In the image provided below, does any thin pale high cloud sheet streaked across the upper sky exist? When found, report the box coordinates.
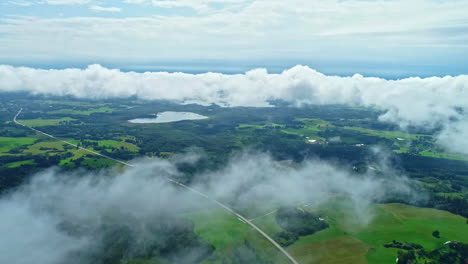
[0,0,468,61]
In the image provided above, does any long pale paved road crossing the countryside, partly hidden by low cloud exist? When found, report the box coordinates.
[13,108,299,264]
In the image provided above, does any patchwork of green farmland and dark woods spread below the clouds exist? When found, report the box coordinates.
[0,94,468,264]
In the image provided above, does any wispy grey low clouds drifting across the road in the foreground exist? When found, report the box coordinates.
[0,154,411,264]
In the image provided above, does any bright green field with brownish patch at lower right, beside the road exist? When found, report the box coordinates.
[255,200,468,264]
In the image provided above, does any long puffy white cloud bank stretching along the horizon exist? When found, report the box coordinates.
[0,65,468,154]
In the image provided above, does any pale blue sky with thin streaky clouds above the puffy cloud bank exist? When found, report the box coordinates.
[0,0,468,76]
